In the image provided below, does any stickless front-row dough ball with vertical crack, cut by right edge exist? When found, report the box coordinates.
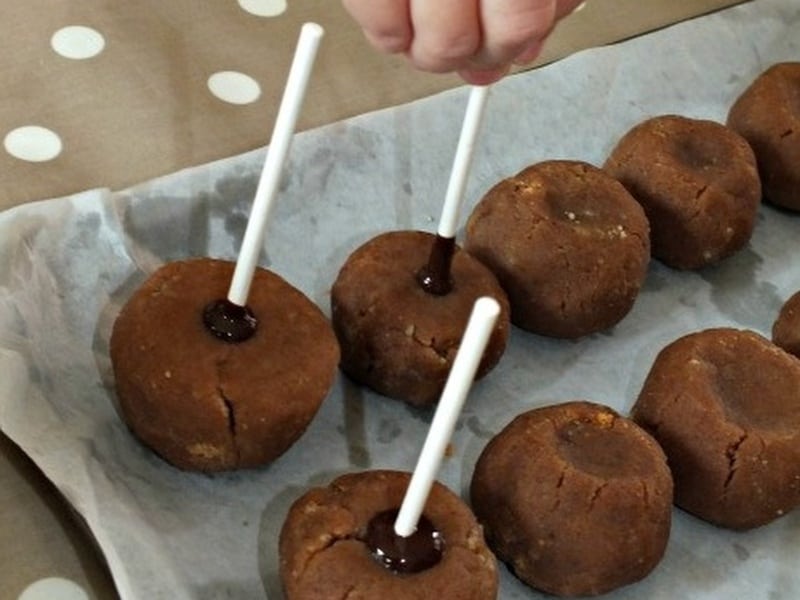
[632,328,800,529]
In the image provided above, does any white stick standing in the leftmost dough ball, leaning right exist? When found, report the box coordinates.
[228,23,324,306]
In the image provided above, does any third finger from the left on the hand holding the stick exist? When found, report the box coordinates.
[475,0,557,66]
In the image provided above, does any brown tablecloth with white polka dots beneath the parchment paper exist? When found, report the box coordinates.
[0,0,757,600]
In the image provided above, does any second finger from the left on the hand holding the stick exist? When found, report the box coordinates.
[409,0,481,73]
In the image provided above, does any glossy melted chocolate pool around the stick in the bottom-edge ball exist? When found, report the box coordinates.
[364,509,444,573]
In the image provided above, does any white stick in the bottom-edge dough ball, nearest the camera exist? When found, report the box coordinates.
[394,296,500,537]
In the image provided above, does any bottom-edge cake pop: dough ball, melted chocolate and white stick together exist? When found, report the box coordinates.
[280,297,500,600]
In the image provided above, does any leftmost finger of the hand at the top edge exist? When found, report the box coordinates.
[342,0,414,53]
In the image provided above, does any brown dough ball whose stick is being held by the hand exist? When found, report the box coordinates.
[331,231,510,406]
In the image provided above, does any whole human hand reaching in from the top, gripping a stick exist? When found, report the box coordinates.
[342,0,582,85]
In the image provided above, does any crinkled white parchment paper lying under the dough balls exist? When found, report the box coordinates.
[0,0,800,600]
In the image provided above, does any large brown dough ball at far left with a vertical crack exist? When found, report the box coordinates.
[110,258,339,471]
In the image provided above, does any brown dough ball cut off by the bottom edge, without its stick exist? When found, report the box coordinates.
[279,471,498,600]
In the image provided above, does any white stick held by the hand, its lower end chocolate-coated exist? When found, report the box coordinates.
[437,85,489,238]
